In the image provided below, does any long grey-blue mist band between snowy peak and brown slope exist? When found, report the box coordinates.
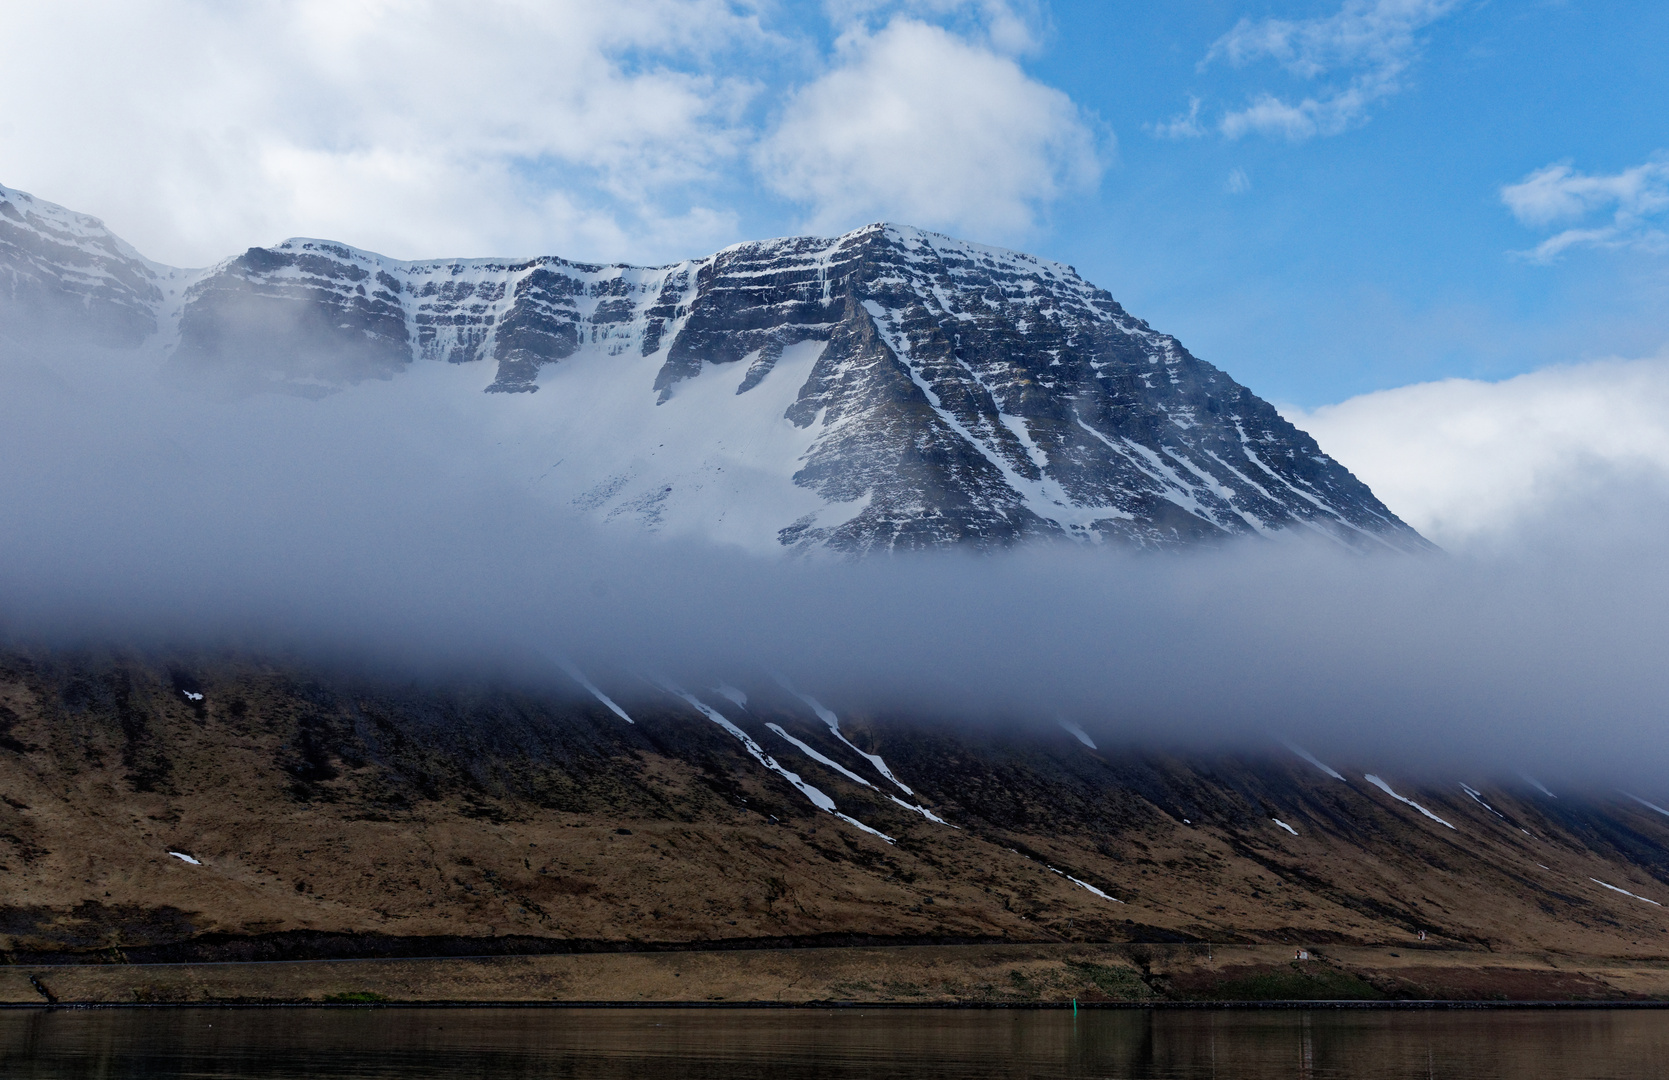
[0,181,1669,785]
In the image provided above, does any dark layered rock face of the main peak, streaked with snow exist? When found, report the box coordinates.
[637,225,1422,551]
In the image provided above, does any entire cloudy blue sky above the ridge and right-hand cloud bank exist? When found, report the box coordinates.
[0,0,1669,409]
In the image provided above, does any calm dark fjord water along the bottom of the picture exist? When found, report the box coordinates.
[0,1008,1669,1080]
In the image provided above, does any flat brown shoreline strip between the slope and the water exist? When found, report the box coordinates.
[0,943,1669,1010]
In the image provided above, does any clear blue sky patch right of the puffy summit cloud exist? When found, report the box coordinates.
[1033,2,1669,404]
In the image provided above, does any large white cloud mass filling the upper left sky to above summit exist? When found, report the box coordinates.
[0,0,1098,265]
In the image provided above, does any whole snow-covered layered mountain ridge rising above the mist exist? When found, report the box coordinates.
[0,187,1427,553]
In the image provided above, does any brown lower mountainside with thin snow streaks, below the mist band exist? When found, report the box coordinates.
[0,654,1669,960]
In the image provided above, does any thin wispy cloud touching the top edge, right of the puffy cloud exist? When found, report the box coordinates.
[1200,0,1460,142]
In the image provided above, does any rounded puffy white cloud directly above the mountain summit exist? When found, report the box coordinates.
[758,17,1100,237]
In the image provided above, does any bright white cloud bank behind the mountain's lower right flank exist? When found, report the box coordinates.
[1285,354,1669,546]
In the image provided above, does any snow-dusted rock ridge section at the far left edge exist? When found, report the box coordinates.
[0,187,164,349]
